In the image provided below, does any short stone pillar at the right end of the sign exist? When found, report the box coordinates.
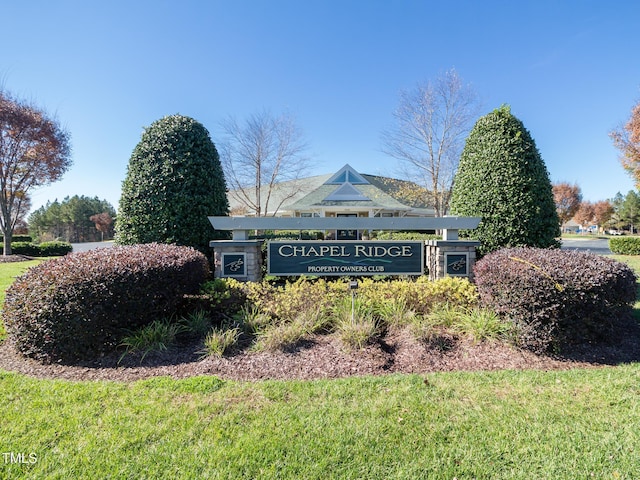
[426,240,480,280]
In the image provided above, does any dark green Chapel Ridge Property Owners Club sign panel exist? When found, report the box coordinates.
[267,241,424,276]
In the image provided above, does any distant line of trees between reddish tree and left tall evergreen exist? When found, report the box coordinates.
[28,195,116,243]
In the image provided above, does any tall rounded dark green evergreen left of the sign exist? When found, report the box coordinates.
[116,115,229,252]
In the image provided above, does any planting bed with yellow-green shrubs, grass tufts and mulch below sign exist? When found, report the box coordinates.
[0,251,638,380]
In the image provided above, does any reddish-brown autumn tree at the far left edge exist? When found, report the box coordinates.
[0,90,71,255]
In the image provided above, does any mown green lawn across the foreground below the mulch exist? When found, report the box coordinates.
[0,258,640,479]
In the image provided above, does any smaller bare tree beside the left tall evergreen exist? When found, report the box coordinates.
[220,111,309,217]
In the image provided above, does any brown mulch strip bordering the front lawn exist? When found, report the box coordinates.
[0,322,640,381]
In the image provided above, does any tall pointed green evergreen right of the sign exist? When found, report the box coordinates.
[451,106,560,254]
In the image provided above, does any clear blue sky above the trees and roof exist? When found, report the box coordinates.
[0,0,640,214]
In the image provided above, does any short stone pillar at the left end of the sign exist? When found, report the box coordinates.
[209,240,263,282]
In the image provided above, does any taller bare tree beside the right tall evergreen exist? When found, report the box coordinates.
[382,69,480,216]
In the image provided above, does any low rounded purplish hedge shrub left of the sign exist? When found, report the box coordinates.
[3,244,209,362]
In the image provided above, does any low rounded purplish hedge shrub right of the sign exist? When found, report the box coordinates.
[474,248,636,353]
